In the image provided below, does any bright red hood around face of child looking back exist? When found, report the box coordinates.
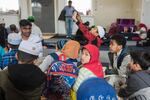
[83,44,104,78]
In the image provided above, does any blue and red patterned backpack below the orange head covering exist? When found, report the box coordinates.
[44,53,78,100]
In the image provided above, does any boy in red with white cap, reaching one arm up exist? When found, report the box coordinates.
[73,12,105,47]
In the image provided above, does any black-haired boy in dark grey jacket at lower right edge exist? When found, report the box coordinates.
[118,51,150,100]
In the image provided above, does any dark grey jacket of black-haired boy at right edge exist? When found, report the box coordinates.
[118,71,150,100]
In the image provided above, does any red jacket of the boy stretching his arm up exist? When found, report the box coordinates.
[77,22,103,48]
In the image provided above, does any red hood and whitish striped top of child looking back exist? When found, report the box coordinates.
[73,44,104,91]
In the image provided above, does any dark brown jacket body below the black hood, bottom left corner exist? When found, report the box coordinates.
[0,70,42,100]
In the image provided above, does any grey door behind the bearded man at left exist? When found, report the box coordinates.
[32,0,55,33]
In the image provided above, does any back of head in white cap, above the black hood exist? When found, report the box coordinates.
[16,40,40,64]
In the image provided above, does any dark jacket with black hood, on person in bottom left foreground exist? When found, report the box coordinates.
[0,64,46,100]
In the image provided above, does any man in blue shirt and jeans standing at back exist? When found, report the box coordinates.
[58,0,75,38]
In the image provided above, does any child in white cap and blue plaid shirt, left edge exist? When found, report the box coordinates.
[0,33,21,69]
